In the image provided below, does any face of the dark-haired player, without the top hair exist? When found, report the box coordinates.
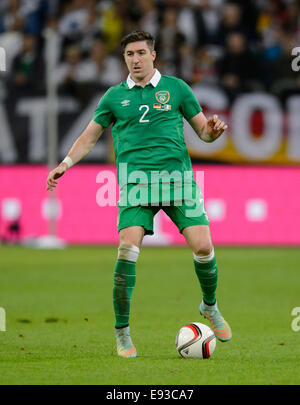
[124,41,156,81]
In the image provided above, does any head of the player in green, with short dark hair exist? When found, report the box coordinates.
[121,31,156,80]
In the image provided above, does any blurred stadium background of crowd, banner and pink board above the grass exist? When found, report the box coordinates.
[0,0,300,246]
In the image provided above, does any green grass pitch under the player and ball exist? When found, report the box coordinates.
[0,247,300,385]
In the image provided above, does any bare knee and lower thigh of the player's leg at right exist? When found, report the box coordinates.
[182,225,213,256]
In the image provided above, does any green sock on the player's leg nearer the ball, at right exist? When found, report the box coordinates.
[194,256,218,305]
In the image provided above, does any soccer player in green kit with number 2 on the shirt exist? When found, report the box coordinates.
[47,31,232,358]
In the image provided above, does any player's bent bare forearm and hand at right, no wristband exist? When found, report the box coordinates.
[189,112,228,142]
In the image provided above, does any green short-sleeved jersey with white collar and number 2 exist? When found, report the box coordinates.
[93,70,202,183]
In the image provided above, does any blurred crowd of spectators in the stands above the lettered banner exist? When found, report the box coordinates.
[0,0,300,102]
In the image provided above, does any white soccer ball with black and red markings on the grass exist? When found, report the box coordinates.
[175,322,216,359]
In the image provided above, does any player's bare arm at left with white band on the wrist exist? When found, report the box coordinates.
[47,120,104,191]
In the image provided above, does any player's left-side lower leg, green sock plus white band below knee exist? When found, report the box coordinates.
[113,244,139,328]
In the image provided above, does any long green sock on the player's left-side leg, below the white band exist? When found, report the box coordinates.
[113,259,135,328]
